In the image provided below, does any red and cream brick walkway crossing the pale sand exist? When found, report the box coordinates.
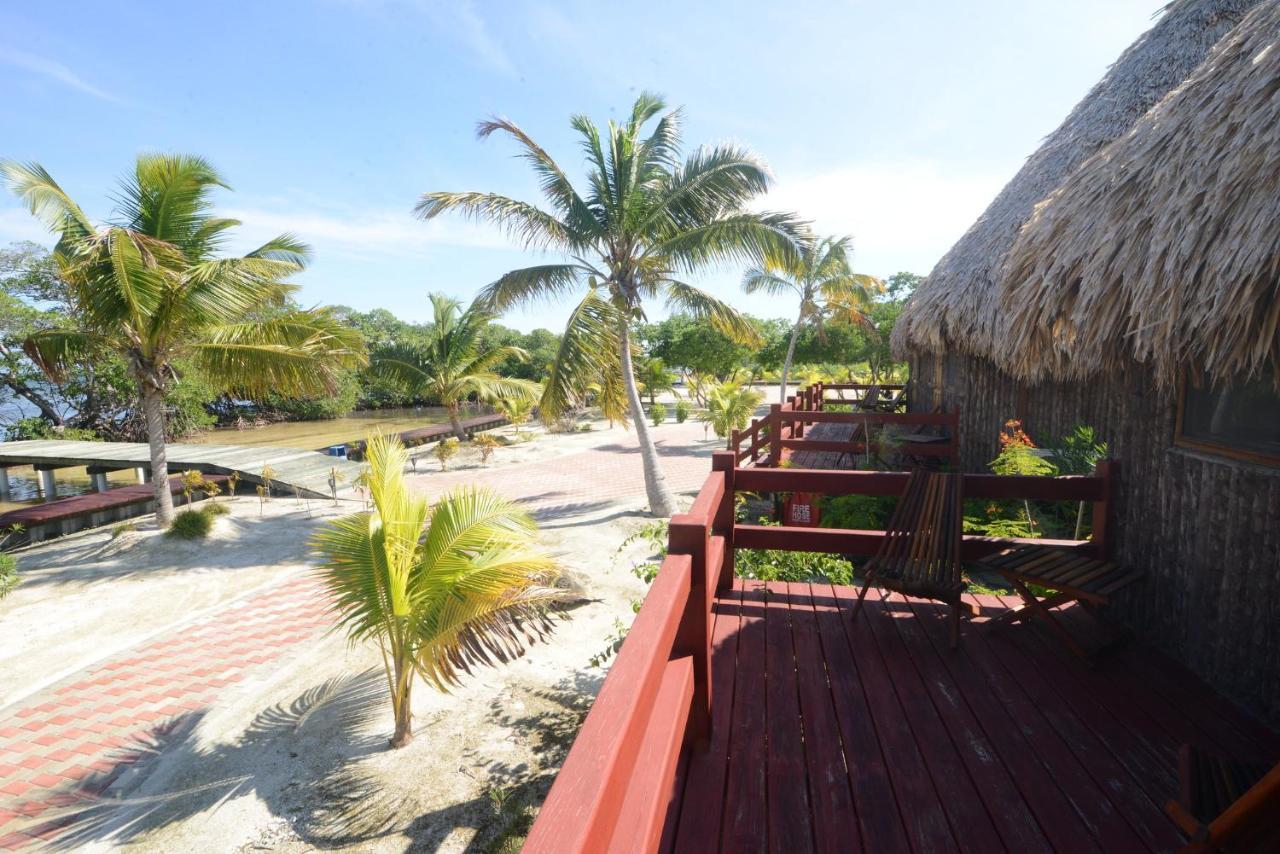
[0,424,709,850]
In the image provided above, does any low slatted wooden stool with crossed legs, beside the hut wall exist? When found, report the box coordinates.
[980,545,1142,659]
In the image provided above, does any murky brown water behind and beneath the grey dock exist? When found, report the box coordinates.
[0,406,460,512]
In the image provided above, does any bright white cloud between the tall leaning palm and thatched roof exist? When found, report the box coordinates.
[764,160,1009,275]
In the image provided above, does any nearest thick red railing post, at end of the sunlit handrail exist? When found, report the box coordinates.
[667,513,712,744]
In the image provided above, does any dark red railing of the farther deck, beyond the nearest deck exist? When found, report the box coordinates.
[728,383,960,467]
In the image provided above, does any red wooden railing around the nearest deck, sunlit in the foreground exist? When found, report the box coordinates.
[525,451,1116,854]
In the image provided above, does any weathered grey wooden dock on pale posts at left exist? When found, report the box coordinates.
[0,440,362,498]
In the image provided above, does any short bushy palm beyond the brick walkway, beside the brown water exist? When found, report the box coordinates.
[371,293,538,439]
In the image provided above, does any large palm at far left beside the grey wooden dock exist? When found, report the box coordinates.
[0,154,364,525]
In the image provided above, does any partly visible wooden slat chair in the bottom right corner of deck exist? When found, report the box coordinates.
[1165,744,1280,853]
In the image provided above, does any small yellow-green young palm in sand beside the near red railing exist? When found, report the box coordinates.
[312,435,559,748]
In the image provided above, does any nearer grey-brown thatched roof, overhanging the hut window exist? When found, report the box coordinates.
[993,0,1280,383]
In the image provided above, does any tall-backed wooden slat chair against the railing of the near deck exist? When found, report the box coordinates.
[852,469,965,649]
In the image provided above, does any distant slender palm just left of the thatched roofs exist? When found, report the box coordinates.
[742,237,884,403]
